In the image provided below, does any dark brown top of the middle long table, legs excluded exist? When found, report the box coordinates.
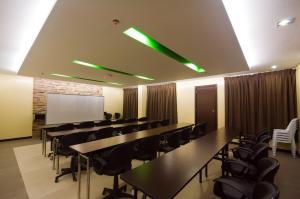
[70,123,193,154]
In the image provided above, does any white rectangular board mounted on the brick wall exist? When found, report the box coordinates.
[46,93,104,124]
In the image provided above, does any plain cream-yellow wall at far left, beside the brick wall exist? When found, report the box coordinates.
[0,74,33,140]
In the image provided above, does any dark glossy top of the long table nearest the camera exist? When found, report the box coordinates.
[121,128,236,199]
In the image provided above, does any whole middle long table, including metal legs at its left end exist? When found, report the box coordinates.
[70,123,193,199]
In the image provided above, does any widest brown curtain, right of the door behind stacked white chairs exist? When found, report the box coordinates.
[225,69,297,134]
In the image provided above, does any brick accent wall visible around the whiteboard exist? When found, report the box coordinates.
[32,78,103,136]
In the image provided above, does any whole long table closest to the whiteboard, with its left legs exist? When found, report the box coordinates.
[42,121,151,157]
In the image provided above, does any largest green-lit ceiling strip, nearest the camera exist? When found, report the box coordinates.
[123,27,205,73]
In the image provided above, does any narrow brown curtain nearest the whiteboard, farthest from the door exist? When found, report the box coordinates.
[123,88,138,119]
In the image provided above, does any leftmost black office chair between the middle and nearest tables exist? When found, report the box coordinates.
[93,143,133,198]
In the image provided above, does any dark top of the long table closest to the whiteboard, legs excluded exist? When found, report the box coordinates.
[47,121,150,137]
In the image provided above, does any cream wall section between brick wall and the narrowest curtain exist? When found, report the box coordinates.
[102,86,123,115]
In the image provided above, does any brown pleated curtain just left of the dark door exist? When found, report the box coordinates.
[147,83,177,124]
